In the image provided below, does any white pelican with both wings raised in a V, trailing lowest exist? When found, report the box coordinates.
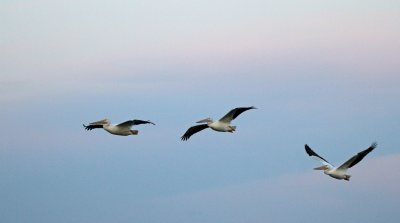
[305,142,378,181]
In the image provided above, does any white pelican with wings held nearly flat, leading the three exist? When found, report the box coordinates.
[83,119,155,136]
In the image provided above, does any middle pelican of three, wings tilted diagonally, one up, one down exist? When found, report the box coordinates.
[181,106,255,141]
